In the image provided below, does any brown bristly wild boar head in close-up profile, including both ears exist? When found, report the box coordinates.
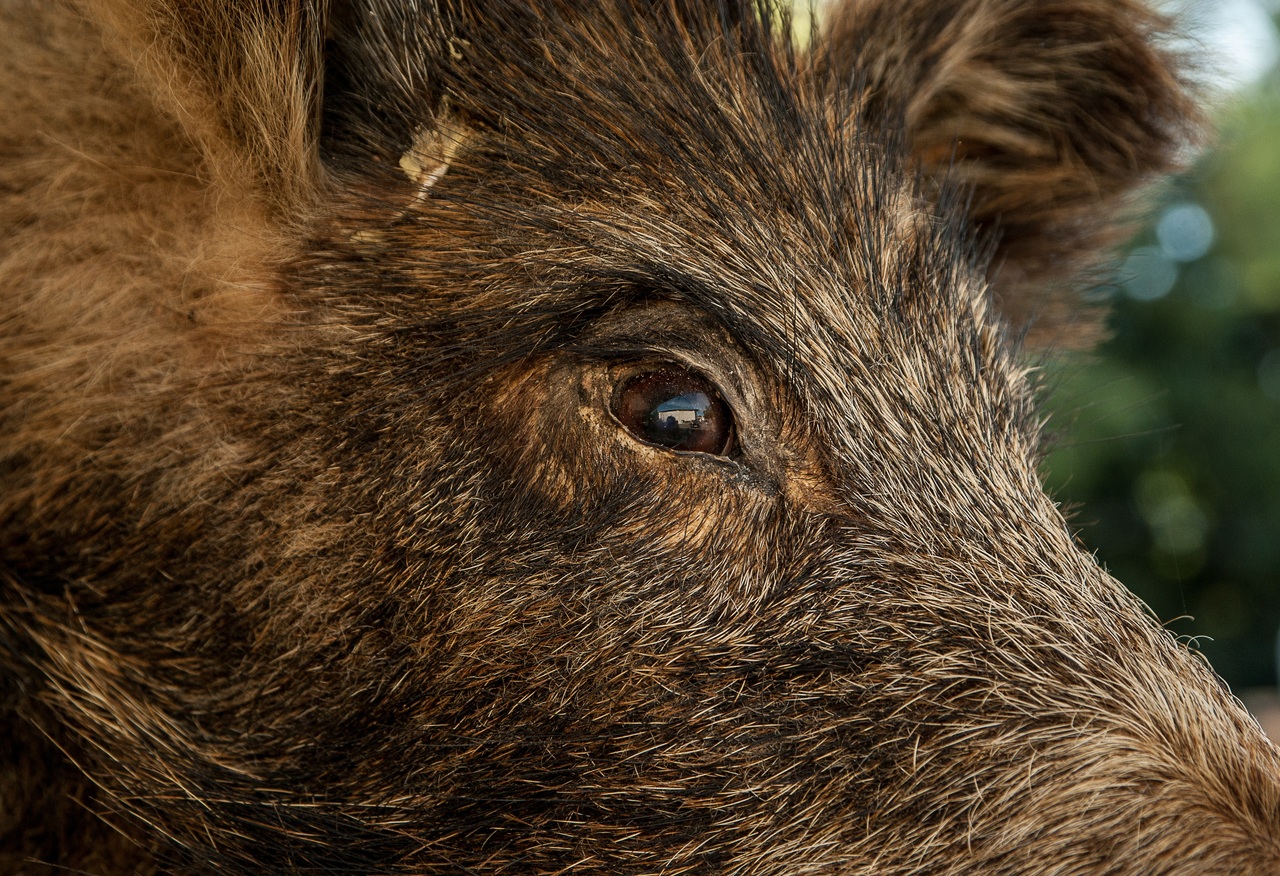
[0,0,1280,876]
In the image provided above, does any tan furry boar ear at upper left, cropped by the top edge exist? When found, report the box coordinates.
[88,0,326,209]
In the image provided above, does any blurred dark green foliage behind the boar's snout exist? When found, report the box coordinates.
[1044,49,1280,689]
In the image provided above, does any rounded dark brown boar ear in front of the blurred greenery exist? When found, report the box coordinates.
[817,0,1201,346]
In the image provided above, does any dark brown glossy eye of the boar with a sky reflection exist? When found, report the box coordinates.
[613,366,733,456]
